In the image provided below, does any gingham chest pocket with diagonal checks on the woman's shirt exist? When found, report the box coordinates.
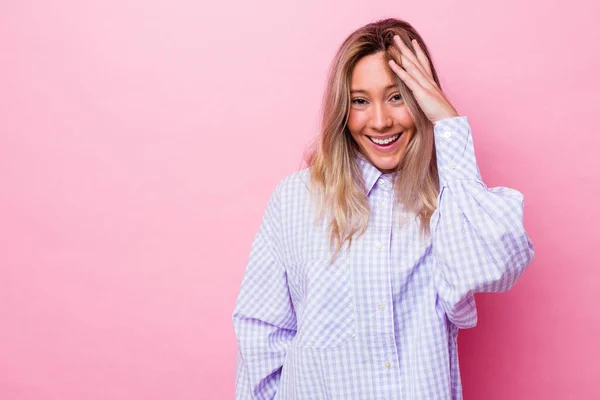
[290,254,356,349]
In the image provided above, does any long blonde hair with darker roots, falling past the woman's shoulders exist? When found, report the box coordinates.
[306,18,441,258]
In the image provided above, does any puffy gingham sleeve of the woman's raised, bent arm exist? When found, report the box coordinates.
[430,117,534,328]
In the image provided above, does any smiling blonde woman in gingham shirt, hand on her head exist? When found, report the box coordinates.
[233,19,534,400]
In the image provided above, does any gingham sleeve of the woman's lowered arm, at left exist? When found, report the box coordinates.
[232,182,296,400]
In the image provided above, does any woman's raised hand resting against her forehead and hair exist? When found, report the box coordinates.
[389,35,458,124]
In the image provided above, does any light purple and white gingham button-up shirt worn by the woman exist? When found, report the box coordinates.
[233,116,534,400]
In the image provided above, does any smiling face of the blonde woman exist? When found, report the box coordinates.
[348,51,415,173]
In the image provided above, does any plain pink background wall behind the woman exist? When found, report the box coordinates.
[0,0,600,400]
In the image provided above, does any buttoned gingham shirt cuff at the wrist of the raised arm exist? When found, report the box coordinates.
[433,116,482,185]
